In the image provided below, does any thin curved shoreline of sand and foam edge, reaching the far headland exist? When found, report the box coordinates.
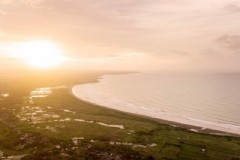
[71,76,240,137]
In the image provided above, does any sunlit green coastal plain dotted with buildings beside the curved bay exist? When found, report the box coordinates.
[0,75,240,160]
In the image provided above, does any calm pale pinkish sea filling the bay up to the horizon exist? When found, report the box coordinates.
[73,73,240,133]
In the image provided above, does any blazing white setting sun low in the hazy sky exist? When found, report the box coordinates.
[15,40,66,69]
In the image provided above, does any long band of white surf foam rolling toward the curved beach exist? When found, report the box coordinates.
[72,75,240,135]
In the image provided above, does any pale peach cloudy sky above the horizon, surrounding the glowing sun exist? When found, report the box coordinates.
[0,0,240,72]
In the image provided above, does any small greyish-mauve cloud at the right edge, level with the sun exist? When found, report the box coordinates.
[216,35,240,50]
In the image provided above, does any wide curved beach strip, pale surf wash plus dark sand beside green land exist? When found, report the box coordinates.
[72,83,240,136]
